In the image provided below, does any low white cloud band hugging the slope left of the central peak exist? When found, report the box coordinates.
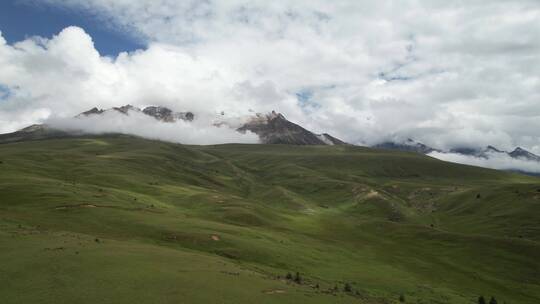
[45,111,259,145]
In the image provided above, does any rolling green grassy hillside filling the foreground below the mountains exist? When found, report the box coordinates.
[0,136,540,303]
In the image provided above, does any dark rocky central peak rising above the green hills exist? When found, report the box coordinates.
[237,111,346,145]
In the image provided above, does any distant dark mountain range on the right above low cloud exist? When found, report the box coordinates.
[372,138,540,162]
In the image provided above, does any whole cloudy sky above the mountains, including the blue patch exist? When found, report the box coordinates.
[0,0,540,154]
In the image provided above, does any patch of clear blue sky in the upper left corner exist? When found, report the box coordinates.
[0,0,145,56]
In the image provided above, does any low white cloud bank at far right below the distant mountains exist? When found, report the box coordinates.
[428,152,540,173]
